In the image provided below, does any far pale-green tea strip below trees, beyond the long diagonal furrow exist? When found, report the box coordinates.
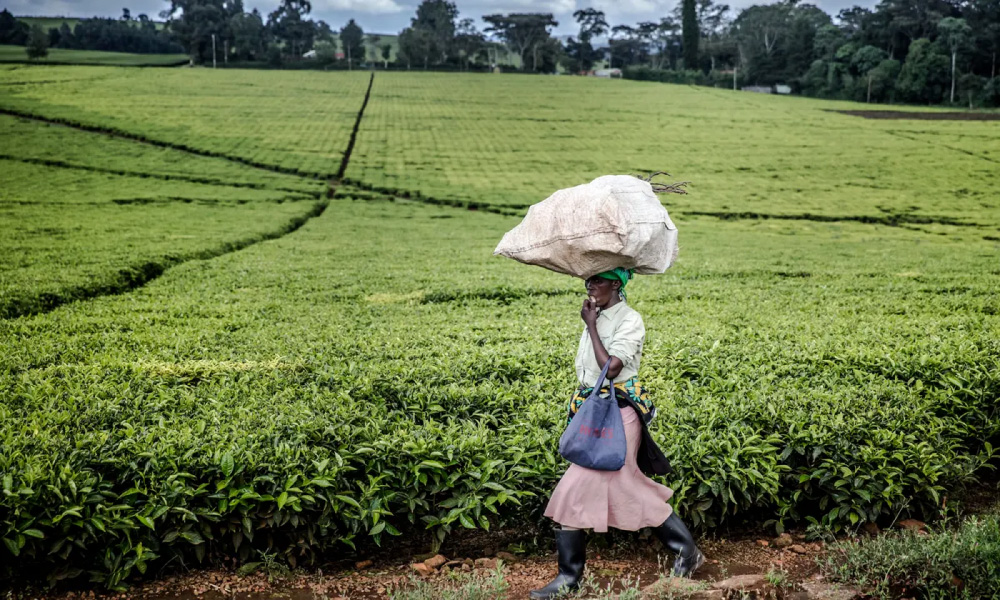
[0,67,1000,230]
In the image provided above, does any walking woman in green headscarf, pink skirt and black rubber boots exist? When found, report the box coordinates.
[531,268,705,598]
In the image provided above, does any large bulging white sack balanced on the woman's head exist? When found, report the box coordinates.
[493,175,677,278]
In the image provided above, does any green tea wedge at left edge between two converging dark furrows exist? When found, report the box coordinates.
[0,115,324,318]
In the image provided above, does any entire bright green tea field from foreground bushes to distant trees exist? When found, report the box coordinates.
[0,67,1000,587]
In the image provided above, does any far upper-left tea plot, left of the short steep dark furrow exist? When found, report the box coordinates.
[0,67,368,179]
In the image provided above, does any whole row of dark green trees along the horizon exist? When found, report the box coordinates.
[7,0,1000,106]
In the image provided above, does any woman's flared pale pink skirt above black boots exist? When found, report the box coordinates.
[545,407,674,533]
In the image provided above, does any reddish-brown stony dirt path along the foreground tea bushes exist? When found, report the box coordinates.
[25,534,853,600]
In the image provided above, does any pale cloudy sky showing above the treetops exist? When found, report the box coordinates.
[0,0,877,34]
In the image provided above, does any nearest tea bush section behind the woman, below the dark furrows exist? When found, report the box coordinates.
[0,200,1000,586]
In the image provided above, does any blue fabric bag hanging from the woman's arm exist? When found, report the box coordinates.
[559,359,628,471]
